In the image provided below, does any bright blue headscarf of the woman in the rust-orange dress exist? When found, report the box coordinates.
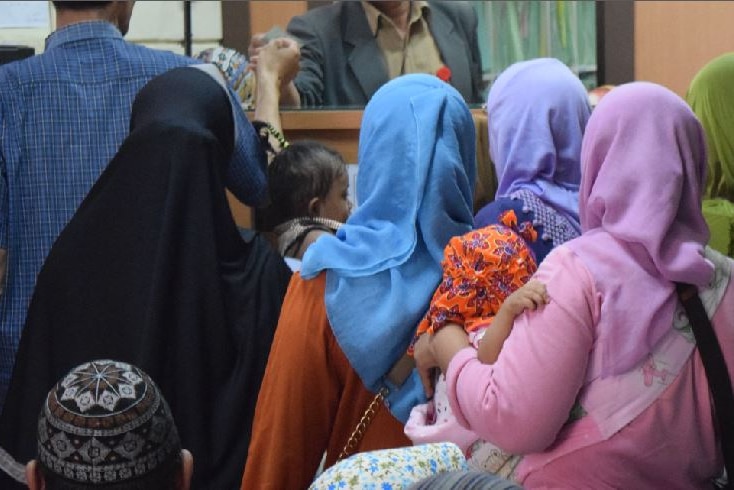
[301,75,476,422]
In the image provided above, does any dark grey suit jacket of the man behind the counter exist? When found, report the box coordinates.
[288,1,482,107]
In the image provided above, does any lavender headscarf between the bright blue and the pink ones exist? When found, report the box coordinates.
[487,58,590,232]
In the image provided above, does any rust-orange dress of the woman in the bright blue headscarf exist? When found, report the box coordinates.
[241,273,411,489]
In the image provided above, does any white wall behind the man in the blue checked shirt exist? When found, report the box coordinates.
[0,0,222,54]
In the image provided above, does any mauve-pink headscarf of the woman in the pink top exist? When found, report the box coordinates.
[568,82,714,377]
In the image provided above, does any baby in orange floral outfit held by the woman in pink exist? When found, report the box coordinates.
[405,215,548,476]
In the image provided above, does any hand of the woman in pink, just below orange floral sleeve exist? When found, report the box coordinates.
[413,323,471,398]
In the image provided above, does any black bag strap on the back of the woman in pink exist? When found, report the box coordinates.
[676,283,734,488]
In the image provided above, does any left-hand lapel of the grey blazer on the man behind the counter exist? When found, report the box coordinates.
[344,2,388,100]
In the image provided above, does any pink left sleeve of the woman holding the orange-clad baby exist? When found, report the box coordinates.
[446,246,601,454]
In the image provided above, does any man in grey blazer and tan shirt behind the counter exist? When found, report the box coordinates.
[249,0,482,107]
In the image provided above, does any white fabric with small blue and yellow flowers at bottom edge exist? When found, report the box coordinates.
[309,443,468,490]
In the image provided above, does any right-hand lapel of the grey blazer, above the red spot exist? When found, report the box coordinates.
[428,8,472,99]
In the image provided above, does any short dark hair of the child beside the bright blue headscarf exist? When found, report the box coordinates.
[265,140,347,228]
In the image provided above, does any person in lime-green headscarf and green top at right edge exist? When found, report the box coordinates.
[686,53,734,257]
